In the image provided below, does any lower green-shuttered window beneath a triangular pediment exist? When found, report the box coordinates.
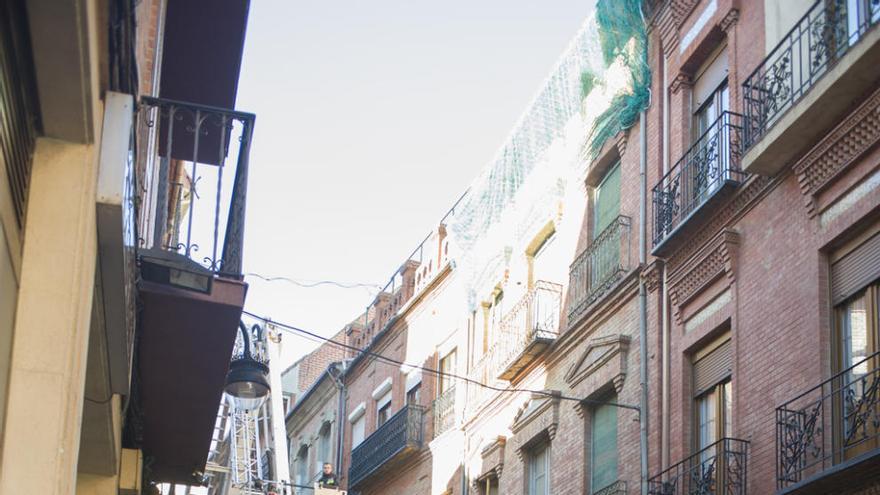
[590,397,617,492]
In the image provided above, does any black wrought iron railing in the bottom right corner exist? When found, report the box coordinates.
[776,353,880,489]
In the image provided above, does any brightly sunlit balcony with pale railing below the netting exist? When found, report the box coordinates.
[488,280,562,380]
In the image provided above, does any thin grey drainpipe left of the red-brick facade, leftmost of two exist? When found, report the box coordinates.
[639,110,648,495]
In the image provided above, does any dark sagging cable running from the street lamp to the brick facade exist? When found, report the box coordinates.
[242,310,641,412]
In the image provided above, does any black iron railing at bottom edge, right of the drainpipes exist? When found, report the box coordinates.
[648,438,749,495]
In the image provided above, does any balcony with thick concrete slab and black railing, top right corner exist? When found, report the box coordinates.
[742,0,880,175]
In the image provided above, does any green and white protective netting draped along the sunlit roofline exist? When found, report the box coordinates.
[448,0,650,302]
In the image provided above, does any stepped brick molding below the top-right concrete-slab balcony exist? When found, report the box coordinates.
[793,85,880,218]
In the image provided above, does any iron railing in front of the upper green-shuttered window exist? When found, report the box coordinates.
[568,215,632,325]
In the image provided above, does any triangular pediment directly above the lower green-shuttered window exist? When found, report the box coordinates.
[565,334,631,397]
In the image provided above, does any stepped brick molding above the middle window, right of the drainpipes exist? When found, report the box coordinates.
[669,229,739,323]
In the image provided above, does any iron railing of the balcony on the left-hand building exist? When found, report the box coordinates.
[138,97,255,277]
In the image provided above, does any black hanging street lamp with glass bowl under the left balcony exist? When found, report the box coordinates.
[224,322,269,411]
